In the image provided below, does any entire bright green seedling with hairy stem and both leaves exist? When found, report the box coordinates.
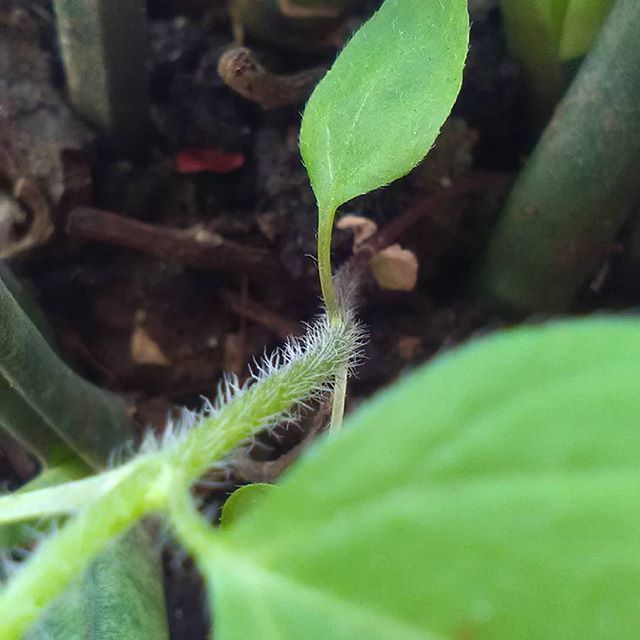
[0,0,640,640]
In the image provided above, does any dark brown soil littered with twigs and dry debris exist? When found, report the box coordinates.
[0,0,640,640]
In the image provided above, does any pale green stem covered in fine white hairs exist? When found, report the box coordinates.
[0,314,359,640]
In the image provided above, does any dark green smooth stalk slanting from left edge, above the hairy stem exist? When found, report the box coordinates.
[0,277,131,467]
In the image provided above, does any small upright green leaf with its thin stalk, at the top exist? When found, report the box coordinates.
[300,0,469,313]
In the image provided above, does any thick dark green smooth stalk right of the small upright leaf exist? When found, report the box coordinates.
[478,0,640,315]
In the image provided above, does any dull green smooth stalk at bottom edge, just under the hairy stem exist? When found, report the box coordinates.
[25,526,169,640]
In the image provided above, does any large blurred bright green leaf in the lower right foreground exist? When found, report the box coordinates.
[203,319,640,640]
